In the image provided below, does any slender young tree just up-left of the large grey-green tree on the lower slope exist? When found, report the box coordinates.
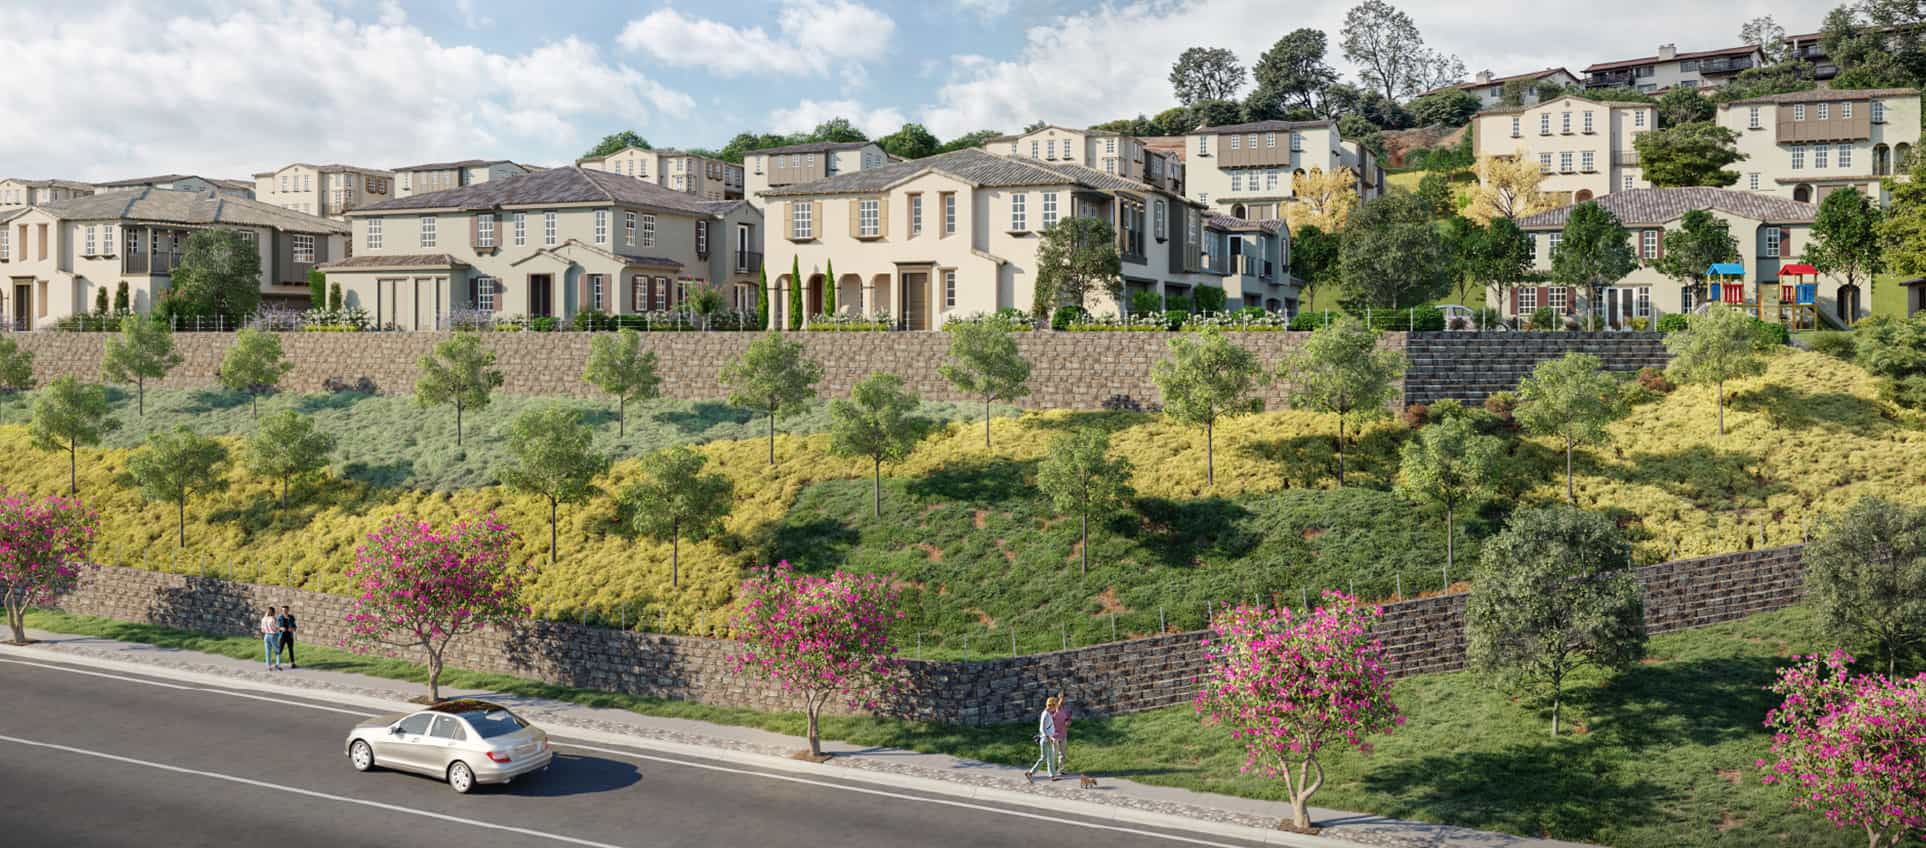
[1396,416,1504,586]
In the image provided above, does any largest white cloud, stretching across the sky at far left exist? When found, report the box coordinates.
[0,0,695,179]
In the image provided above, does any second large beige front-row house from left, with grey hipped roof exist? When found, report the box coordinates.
[322,166,763,330]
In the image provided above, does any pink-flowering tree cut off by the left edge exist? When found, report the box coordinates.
[0,491,98,646]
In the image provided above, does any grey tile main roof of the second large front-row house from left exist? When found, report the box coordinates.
[349,166,734,216]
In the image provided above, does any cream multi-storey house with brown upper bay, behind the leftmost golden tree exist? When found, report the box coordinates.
[1183,121,1385,220]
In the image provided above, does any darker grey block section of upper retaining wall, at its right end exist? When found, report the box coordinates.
[1404,333,1670,405]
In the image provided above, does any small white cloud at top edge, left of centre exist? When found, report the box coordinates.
[616,0,896,77]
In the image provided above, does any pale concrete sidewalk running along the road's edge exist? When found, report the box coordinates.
[0,630,1581,848]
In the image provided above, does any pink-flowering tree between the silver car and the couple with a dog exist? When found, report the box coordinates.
[730,563,903,757]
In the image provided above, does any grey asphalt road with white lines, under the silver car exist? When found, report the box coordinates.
[0,659,1263,848]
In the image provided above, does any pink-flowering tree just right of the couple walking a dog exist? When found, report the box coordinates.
[1192,592,1404,831]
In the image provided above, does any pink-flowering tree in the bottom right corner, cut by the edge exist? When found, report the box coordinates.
[1757,651,1926,848]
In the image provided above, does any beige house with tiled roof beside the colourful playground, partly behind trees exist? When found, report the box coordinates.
[1491,189,1868,328]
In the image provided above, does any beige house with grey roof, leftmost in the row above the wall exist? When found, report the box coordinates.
[0,189,347,330]
